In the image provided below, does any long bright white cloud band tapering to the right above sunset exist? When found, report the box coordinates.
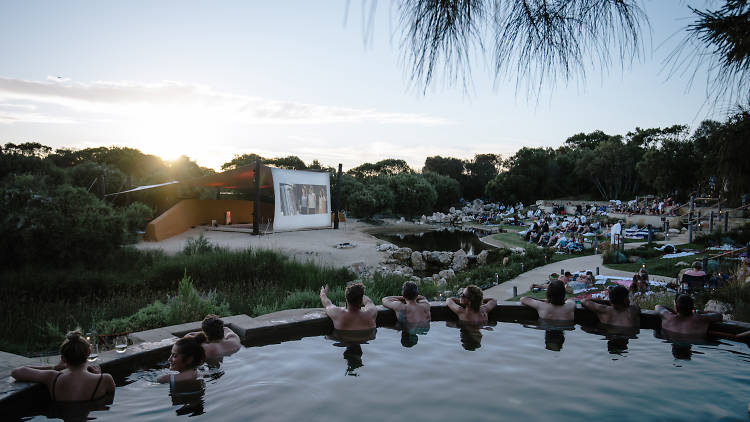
[0,76,451,126]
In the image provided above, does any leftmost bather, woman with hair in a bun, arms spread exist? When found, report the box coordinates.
[11,331,115,402]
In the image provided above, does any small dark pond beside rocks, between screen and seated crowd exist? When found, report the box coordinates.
[374,229,493,255]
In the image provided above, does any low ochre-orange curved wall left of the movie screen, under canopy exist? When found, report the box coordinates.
[145,199,258,241]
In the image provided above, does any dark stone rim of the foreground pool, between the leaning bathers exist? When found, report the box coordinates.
[0,302,750,418]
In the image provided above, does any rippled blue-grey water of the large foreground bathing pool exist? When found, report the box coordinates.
[16,322,750,421]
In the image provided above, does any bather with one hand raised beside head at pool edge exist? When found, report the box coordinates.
[320,283,378,331]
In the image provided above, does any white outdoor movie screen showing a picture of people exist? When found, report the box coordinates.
[271,168,331,231]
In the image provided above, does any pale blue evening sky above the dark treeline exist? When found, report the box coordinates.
[0,0,724,169]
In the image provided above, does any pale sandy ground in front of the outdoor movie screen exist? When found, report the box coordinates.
[136,219,434,267]
